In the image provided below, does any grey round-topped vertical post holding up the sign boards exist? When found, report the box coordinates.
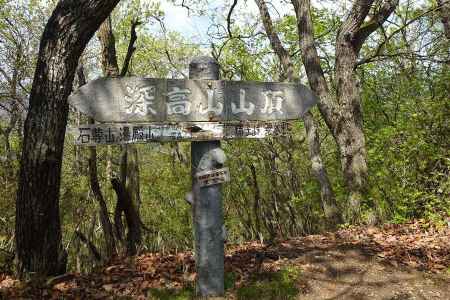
[189,56,225,297]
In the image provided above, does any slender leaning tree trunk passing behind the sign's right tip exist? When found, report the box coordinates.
[255,0,342,227]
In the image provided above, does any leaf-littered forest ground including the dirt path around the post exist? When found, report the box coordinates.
[0,222,450,300]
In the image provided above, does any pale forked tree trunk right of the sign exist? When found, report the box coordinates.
[292,0,398,221]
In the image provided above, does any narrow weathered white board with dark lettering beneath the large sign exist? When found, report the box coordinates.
[68,121,291,146]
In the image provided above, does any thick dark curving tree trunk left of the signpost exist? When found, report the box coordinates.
[16,0,119,275]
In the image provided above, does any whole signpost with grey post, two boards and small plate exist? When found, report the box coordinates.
[69,57,317,296]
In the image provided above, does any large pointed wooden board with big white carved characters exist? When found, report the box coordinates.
[69,77,317,123]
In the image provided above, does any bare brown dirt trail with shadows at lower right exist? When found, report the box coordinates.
[286,246,450,300]
